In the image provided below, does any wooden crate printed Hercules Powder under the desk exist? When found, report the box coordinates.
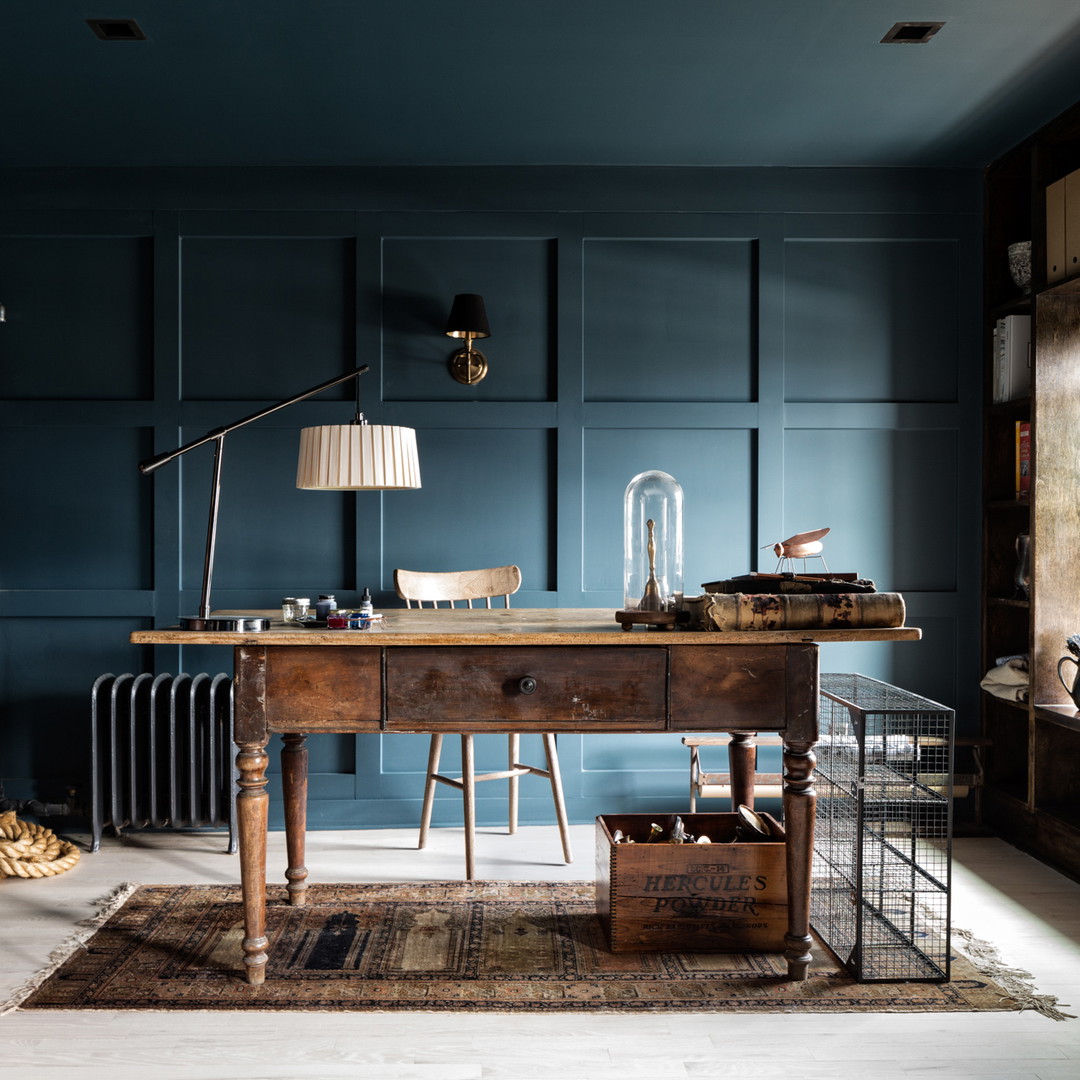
[596,813,787,953]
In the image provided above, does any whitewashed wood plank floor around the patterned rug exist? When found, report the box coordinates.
[0,825,1080,1080]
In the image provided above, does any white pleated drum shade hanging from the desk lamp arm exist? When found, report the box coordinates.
[296,423,420,491]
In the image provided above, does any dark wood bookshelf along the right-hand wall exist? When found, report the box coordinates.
[982,97,1080,876]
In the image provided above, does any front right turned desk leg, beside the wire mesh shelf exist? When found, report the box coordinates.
[784,742,816,982]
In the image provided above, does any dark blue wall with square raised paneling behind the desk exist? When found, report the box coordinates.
[0,168,981,826]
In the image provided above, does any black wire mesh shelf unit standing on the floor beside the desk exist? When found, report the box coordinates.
[811,674,955,982]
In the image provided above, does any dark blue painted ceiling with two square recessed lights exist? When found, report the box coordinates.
[6,0,1080,167]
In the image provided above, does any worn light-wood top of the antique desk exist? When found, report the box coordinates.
[131,608,922,647]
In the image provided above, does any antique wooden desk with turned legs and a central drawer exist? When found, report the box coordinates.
[131,608,920,983]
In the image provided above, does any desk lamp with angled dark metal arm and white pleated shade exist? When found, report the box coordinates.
[138,364,420,632]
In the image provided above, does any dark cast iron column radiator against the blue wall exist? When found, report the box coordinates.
[90,672,238,854]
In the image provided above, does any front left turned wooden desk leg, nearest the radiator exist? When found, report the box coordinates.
[237,739,270,986]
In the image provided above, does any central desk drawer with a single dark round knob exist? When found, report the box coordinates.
[387,646,667,731]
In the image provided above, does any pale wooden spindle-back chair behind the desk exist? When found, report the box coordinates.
[394,566,573,880]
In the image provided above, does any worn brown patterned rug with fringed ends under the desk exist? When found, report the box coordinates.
[9,881,1067,1012]
